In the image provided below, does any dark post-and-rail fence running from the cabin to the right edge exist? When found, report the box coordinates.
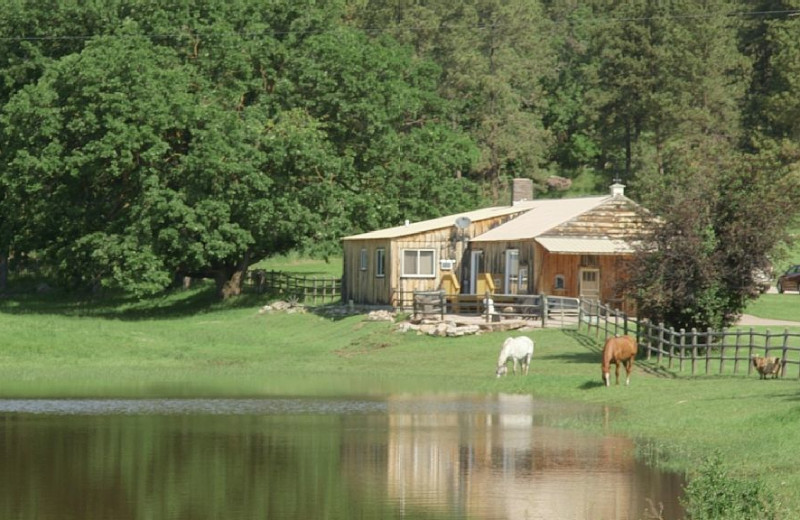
[580,301,800,378]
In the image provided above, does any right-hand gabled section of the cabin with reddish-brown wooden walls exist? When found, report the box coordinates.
[470,184,653,311]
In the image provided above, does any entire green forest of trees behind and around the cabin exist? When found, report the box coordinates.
[0,0,800,323]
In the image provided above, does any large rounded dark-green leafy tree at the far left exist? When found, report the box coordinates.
[2,26,274,293]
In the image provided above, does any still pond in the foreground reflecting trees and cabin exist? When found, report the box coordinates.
[0,395,683,520]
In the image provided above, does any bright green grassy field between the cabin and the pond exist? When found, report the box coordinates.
[0,278,800,518]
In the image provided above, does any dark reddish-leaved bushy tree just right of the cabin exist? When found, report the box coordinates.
[627,147,800,329]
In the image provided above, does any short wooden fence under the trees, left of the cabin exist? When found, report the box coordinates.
[247,269,342,305]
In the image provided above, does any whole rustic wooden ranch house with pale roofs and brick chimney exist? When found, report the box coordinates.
[342,179,653,307]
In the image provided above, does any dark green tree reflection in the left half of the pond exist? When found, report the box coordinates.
[0,416,366,520]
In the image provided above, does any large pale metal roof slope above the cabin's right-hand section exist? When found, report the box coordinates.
[470,195,611,242]
